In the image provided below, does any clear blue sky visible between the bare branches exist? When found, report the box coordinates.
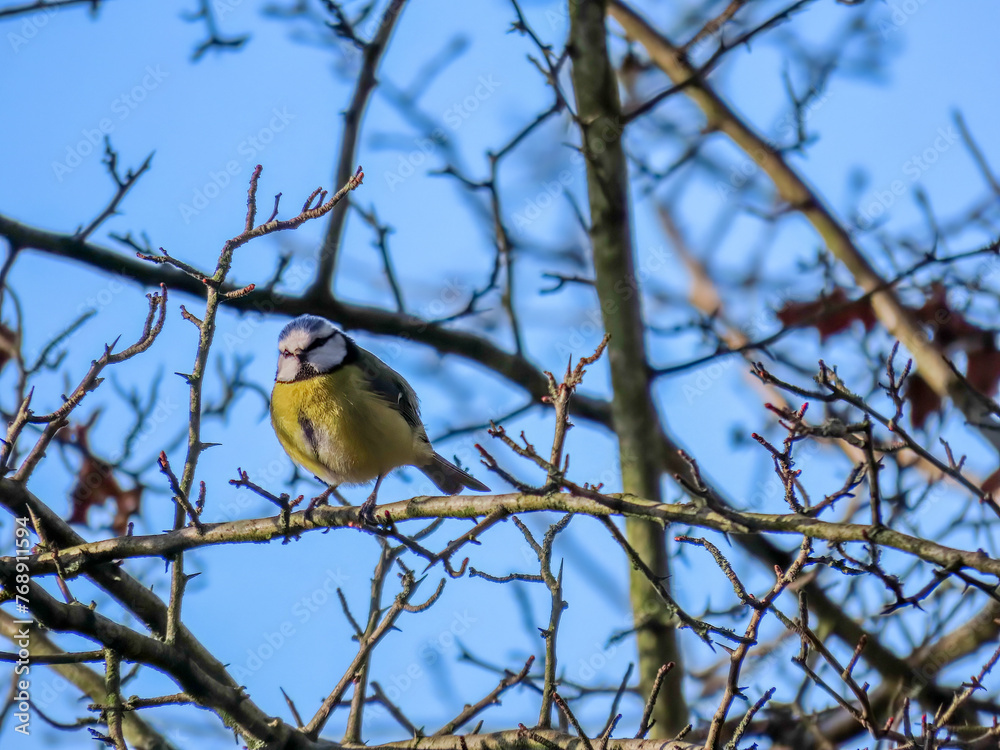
[0,0,1000,748]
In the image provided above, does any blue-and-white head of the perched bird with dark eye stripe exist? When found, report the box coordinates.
[274,315,353,383]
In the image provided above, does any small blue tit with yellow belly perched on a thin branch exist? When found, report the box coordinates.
[271,315,490,521]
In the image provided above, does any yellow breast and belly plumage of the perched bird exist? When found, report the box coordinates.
[271,367,431,484]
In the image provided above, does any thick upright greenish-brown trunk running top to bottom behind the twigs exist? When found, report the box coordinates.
[570,0,687,737]
